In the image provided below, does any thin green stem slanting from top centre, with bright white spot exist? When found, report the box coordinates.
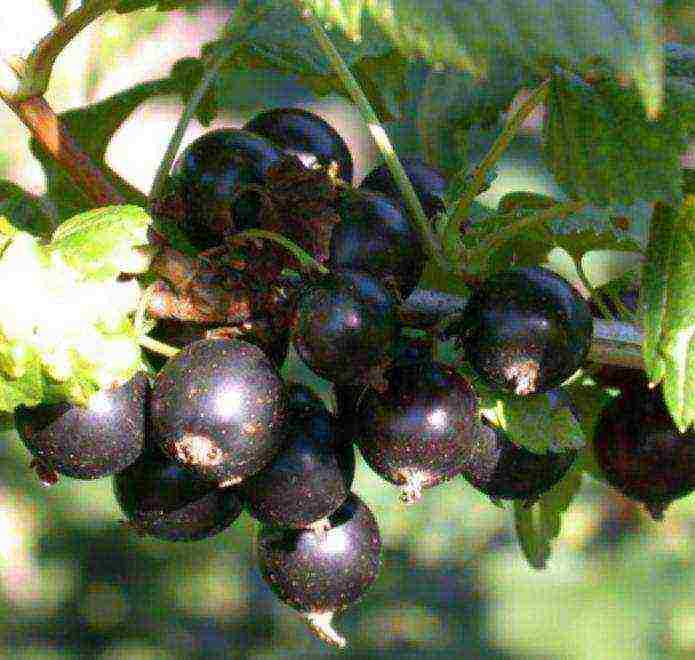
[292,0,452,270]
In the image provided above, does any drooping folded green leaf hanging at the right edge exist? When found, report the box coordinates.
[642,195,695,432]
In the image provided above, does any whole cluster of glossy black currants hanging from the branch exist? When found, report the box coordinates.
[17,109,692,646]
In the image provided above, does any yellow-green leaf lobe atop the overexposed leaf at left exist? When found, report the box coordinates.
[47,206,151,280]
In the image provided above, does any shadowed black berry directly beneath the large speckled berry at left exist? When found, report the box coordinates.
[113,450,242,541]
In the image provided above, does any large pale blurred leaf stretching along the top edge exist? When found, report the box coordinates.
[298,0,663,112]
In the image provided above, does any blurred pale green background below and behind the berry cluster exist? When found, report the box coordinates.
[0,0,695,660]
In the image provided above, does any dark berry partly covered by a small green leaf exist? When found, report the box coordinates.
[462,422,577,502]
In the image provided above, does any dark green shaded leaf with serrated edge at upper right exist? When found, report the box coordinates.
[544,69,695,207]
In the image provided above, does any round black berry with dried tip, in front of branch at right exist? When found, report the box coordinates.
[452,267,593,396]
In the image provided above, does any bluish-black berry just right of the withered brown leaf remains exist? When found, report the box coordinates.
[328,191,425,298]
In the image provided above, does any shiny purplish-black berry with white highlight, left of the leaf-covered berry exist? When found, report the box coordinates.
[355,361,477,504]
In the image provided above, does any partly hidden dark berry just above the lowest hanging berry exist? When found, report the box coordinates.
[241,384,349,532]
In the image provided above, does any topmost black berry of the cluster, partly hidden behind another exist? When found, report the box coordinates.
[244,108,353,184]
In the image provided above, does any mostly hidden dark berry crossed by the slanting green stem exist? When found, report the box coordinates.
[360,158,448,218]
